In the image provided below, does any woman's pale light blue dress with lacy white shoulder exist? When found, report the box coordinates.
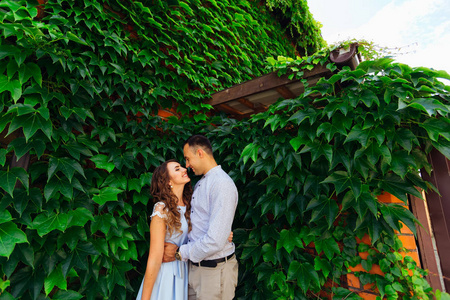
[136,202,188,300]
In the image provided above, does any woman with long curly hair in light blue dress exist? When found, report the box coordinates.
[136,160,192,300]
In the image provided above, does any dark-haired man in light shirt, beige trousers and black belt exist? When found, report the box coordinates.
[164,135,238,300]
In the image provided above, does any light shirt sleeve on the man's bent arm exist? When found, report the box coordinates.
[180,178,238,262]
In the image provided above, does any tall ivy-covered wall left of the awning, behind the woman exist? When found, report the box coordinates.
[0,0,323,299]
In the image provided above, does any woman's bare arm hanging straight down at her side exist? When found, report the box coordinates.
[141,208,166,300]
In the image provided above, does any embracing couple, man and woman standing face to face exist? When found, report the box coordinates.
[136,135,238,300]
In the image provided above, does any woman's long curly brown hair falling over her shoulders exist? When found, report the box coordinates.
[150,159,192,235]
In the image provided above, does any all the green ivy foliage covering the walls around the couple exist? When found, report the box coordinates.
[0,0,450,299]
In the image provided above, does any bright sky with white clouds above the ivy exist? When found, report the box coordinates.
[308,0,450,74]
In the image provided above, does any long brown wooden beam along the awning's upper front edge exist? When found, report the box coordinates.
[207,66,331,106]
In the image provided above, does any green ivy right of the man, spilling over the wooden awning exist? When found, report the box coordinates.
[232,51,450,299]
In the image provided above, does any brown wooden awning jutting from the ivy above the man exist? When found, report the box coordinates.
[207,44,359,119]
